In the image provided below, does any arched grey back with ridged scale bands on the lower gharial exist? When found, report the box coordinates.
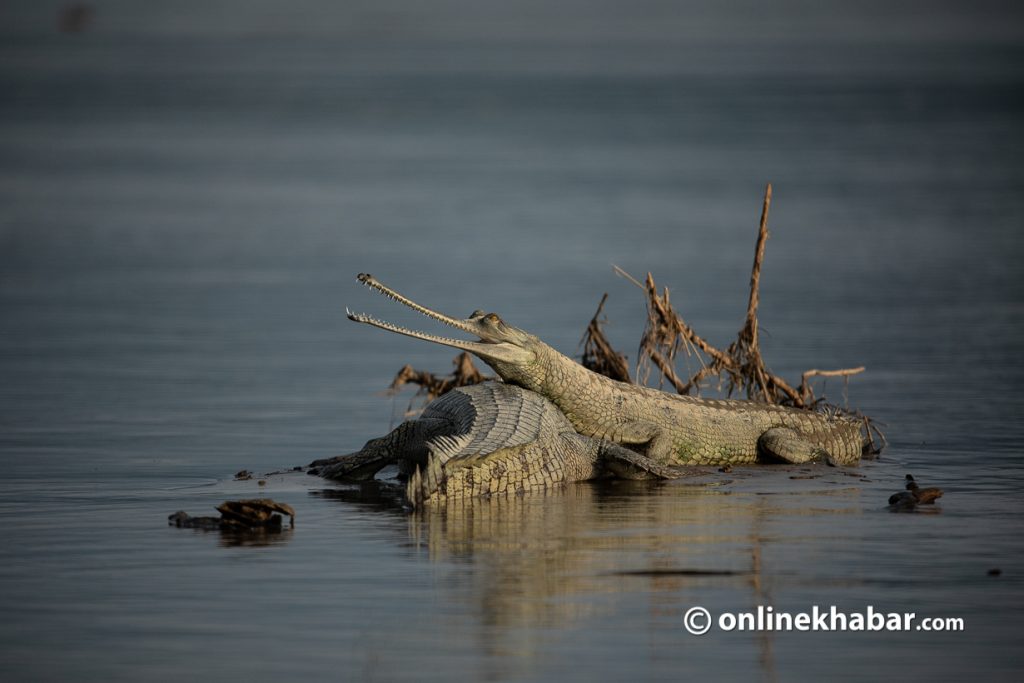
[419,382,573,463]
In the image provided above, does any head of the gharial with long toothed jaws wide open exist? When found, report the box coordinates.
[345,272,549,382]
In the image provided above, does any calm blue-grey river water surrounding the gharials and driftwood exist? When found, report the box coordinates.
[0,1,1024,681]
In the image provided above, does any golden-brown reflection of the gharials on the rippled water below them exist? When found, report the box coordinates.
[314,468,872,678]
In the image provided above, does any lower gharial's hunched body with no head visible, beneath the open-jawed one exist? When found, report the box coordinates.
[312,382,678,507]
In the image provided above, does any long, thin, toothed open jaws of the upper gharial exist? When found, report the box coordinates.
[345,272,534,362]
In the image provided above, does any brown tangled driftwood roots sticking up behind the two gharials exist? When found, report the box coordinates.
[390,184,886,455]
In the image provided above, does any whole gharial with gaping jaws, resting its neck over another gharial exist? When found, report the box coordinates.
[348,274,864,465]
